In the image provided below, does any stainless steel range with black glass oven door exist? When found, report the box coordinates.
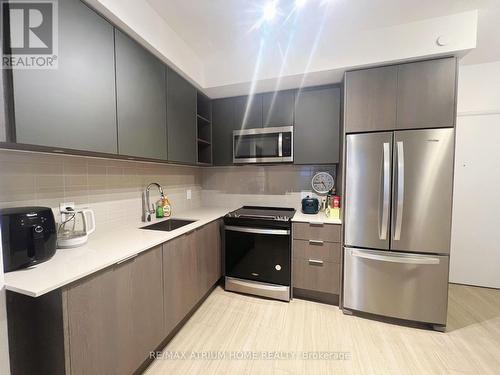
[224,206,295,301]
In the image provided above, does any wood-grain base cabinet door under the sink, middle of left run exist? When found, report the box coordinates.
[163,232,199,334]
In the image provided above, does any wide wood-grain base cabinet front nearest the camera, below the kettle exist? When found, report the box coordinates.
[65,248,165,375]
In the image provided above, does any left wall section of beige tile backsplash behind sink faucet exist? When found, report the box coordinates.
[0,150,201,224]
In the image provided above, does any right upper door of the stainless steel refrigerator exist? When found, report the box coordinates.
[391,129,455,254]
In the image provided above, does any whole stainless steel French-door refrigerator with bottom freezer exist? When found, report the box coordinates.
[343,129,455,329]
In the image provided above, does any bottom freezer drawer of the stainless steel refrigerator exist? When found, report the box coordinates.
[344,247,449,325]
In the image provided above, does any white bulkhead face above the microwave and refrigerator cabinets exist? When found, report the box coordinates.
[204,11,477,97]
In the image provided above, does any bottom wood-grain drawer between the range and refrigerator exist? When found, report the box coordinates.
[293,258,340,294]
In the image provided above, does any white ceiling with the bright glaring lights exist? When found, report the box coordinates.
[146,0,500,94]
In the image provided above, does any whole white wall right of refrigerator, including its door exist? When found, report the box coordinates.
[450,61,500,288]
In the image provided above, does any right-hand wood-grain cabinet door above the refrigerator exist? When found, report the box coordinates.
[397,57,456,129]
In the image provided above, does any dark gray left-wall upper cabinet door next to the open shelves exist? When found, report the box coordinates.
[167,68,197,164]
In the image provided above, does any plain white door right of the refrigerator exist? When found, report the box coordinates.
[450,114,500,288]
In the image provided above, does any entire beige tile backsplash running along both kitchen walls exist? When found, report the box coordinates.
[0,150,336,225]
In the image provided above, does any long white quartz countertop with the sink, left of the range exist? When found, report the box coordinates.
[5,207,237,297]
